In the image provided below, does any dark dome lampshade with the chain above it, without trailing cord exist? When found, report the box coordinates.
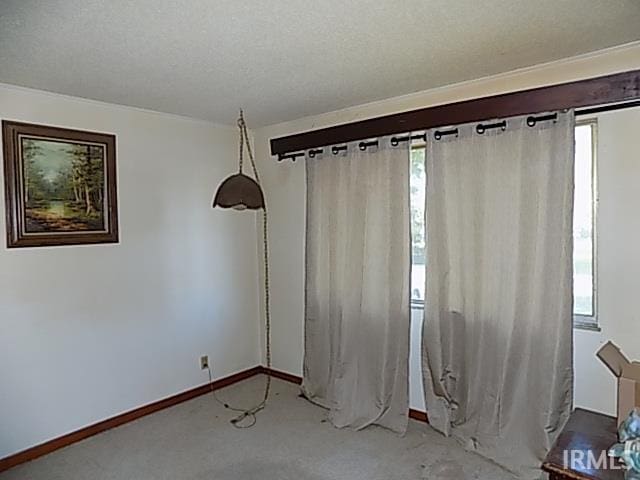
[213,110,264,210]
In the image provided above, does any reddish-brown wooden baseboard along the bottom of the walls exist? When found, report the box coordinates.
[0,366,428,473]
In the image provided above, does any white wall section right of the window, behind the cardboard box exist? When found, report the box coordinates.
[574,108,640,413]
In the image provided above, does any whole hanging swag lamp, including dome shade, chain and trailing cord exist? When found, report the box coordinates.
[211,110,271,428]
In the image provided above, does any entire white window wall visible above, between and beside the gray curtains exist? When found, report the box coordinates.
[255,43,640,413]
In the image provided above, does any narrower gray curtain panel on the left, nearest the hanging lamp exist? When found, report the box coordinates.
[302,138,410,433]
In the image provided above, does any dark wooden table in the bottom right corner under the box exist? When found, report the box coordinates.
[542,408,624,480]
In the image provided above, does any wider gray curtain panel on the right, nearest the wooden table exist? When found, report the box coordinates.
[423,113,574,478]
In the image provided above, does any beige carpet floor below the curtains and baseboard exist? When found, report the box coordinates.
[0,376,514,480]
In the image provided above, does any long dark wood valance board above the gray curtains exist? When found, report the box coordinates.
[271,70,640,158]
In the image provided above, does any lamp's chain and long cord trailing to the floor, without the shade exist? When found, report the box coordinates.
[207,110,271,428]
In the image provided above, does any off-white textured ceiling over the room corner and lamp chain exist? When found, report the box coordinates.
[0,0,640,127]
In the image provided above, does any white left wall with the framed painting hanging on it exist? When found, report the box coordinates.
[0,86,260,458]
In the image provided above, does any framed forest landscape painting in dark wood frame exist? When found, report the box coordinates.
[2,121,118,248]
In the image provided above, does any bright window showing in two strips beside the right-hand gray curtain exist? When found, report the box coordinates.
[410,121,597,328]
